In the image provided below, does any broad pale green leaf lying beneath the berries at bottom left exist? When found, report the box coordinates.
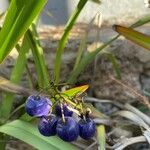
[0,120,77,150]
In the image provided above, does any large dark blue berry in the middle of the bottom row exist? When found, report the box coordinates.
[56,117,79,142]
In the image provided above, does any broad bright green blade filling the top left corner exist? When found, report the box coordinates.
[0,0,46,63]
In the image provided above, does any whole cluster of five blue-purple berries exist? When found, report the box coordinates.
[25,95,96,142]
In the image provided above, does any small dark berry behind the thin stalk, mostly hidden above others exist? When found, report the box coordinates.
[55,104,73,117]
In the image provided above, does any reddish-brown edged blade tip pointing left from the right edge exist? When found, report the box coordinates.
[114,25,150,50]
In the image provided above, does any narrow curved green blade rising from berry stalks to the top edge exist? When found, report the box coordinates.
[54,0,88,84]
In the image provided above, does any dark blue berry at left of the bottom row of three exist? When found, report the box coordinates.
[38,116,57,136]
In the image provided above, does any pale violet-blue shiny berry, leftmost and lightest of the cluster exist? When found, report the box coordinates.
[25,95,52,117]
